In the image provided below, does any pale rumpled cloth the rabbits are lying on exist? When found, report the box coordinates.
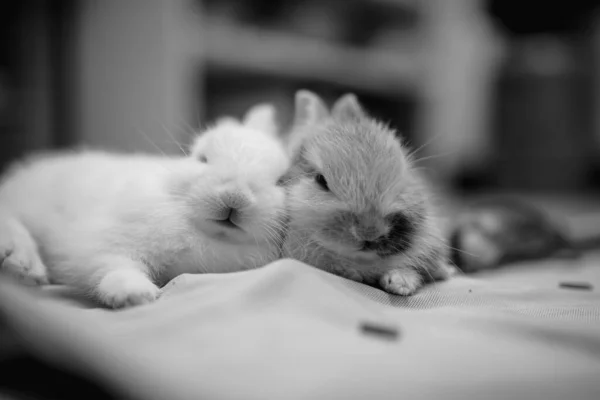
[0,255,600,400]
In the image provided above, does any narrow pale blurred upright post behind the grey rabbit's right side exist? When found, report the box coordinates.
[410,0,505,187]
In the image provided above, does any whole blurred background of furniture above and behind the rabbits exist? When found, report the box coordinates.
[0,0,600,199]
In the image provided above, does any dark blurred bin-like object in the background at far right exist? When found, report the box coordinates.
[493,35,596,192]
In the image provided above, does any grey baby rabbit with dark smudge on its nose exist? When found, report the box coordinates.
[283,90,451,295]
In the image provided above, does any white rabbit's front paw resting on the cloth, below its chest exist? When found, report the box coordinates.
[97,270,160,308]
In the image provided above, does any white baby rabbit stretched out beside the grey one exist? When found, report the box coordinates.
[0,104,289,307]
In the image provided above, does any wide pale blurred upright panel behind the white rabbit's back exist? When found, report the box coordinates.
[73,0,203,153]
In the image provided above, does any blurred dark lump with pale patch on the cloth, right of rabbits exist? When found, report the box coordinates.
[450,197,578,272]
